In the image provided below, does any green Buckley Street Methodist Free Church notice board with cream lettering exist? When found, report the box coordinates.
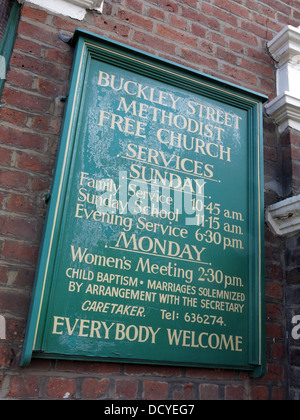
[21,30,266,376]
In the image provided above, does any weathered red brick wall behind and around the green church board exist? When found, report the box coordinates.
[0,0,300,400]
